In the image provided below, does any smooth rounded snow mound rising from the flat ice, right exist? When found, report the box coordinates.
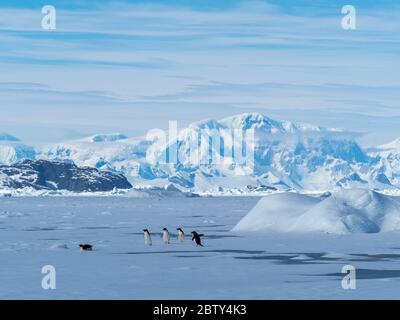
[233,189,400,234]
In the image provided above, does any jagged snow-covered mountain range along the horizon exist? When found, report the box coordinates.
[0,113,400,194]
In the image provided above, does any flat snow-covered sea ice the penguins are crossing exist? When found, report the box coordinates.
[0,197,400,299]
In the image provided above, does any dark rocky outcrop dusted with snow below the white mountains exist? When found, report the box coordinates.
[0,160,132,192]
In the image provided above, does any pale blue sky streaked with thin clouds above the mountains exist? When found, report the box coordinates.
[0,0,400,145]
